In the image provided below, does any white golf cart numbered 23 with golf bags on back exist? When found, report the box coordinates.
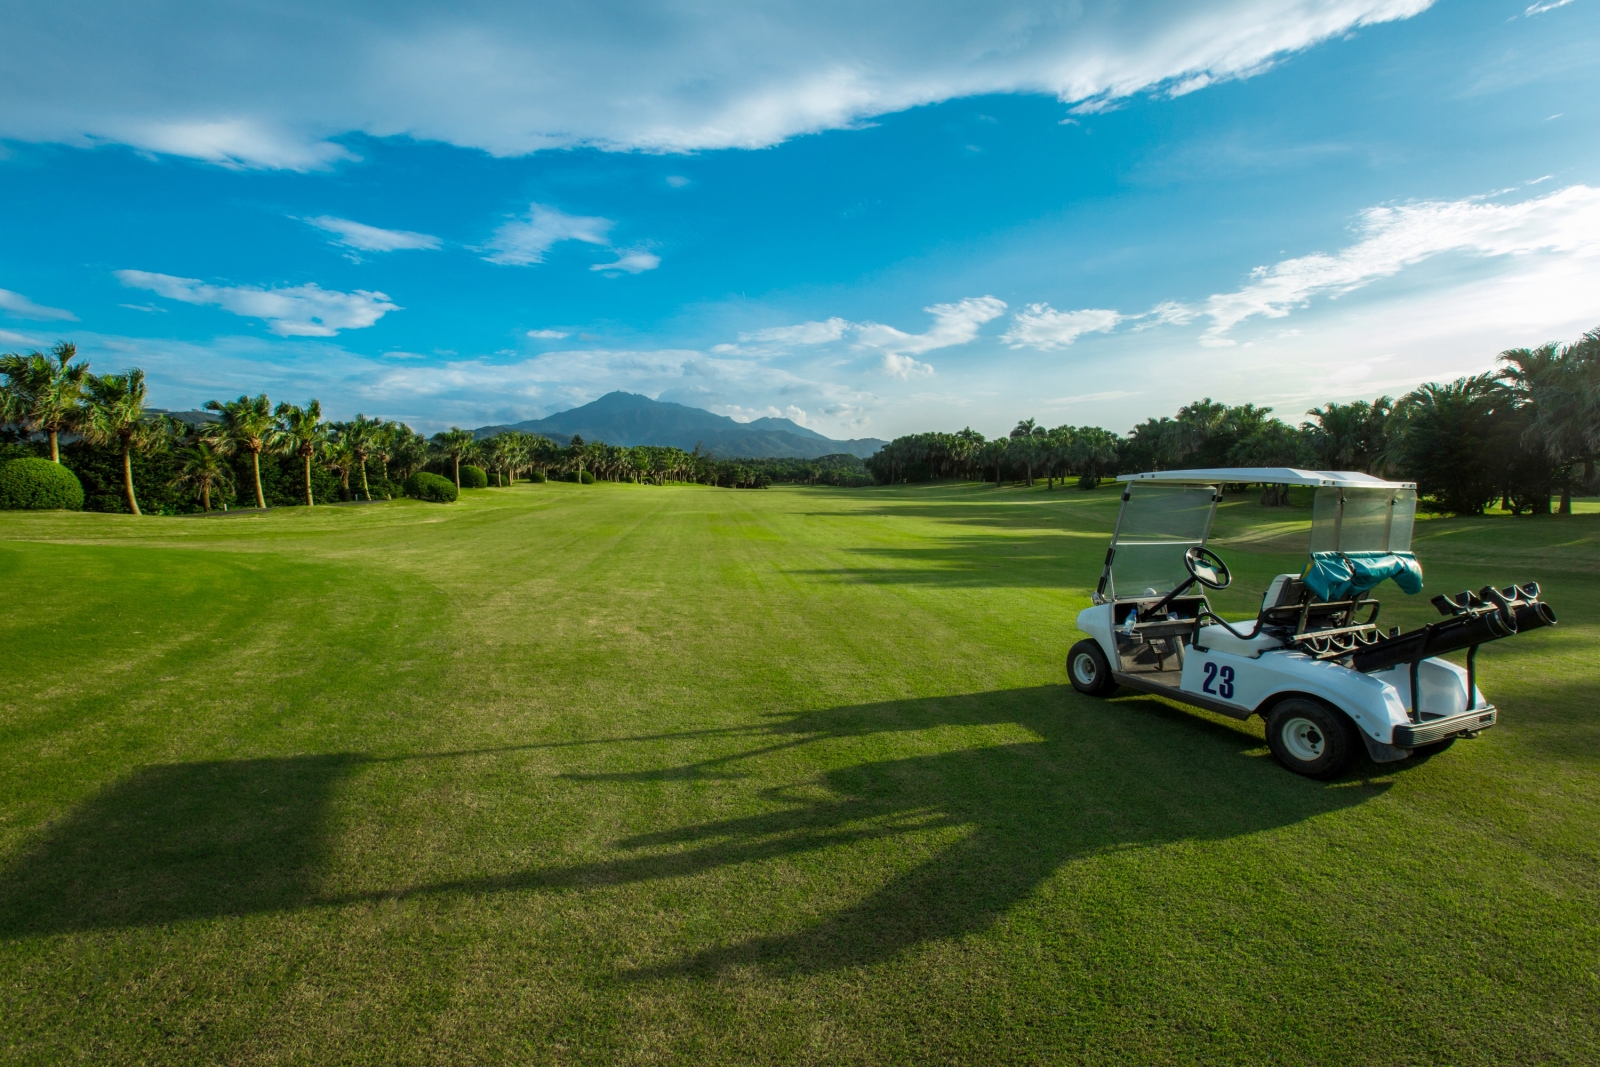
[1067,467,1555,777]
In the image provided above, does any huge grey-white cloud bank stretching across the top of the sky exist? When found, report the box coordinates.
[0,0,1433,170]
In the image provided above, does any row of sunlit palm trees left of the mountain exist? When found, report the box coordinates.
[0,341,872,515]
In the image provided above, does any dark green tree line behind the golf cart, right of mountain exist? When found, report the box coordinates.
[866,330,1600,515]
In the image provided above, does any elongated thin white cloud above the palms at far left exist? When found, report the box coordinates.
[115,270,400,338]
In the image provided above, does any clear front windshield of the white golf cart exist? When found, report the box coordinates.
[1101,483,1216,600]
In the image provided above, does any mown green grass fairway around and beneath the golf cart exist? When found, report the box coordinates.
[0,485,1600,1064]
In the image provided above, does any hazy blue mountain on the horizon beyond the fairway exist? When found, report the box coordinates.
[474,390,883,459]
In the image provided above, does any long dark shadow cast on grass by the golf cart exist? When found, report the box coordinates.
[0,686,1386,979]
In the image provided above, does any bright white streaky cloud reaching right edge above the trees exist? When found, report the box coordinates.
[1200,186,1600,347]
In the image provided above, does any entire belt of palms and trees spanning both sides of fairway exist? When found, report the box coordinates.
[0,330,1600,515]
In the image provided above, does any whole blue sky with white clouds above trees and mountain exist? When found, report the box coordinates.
[0,0,1600,437]
